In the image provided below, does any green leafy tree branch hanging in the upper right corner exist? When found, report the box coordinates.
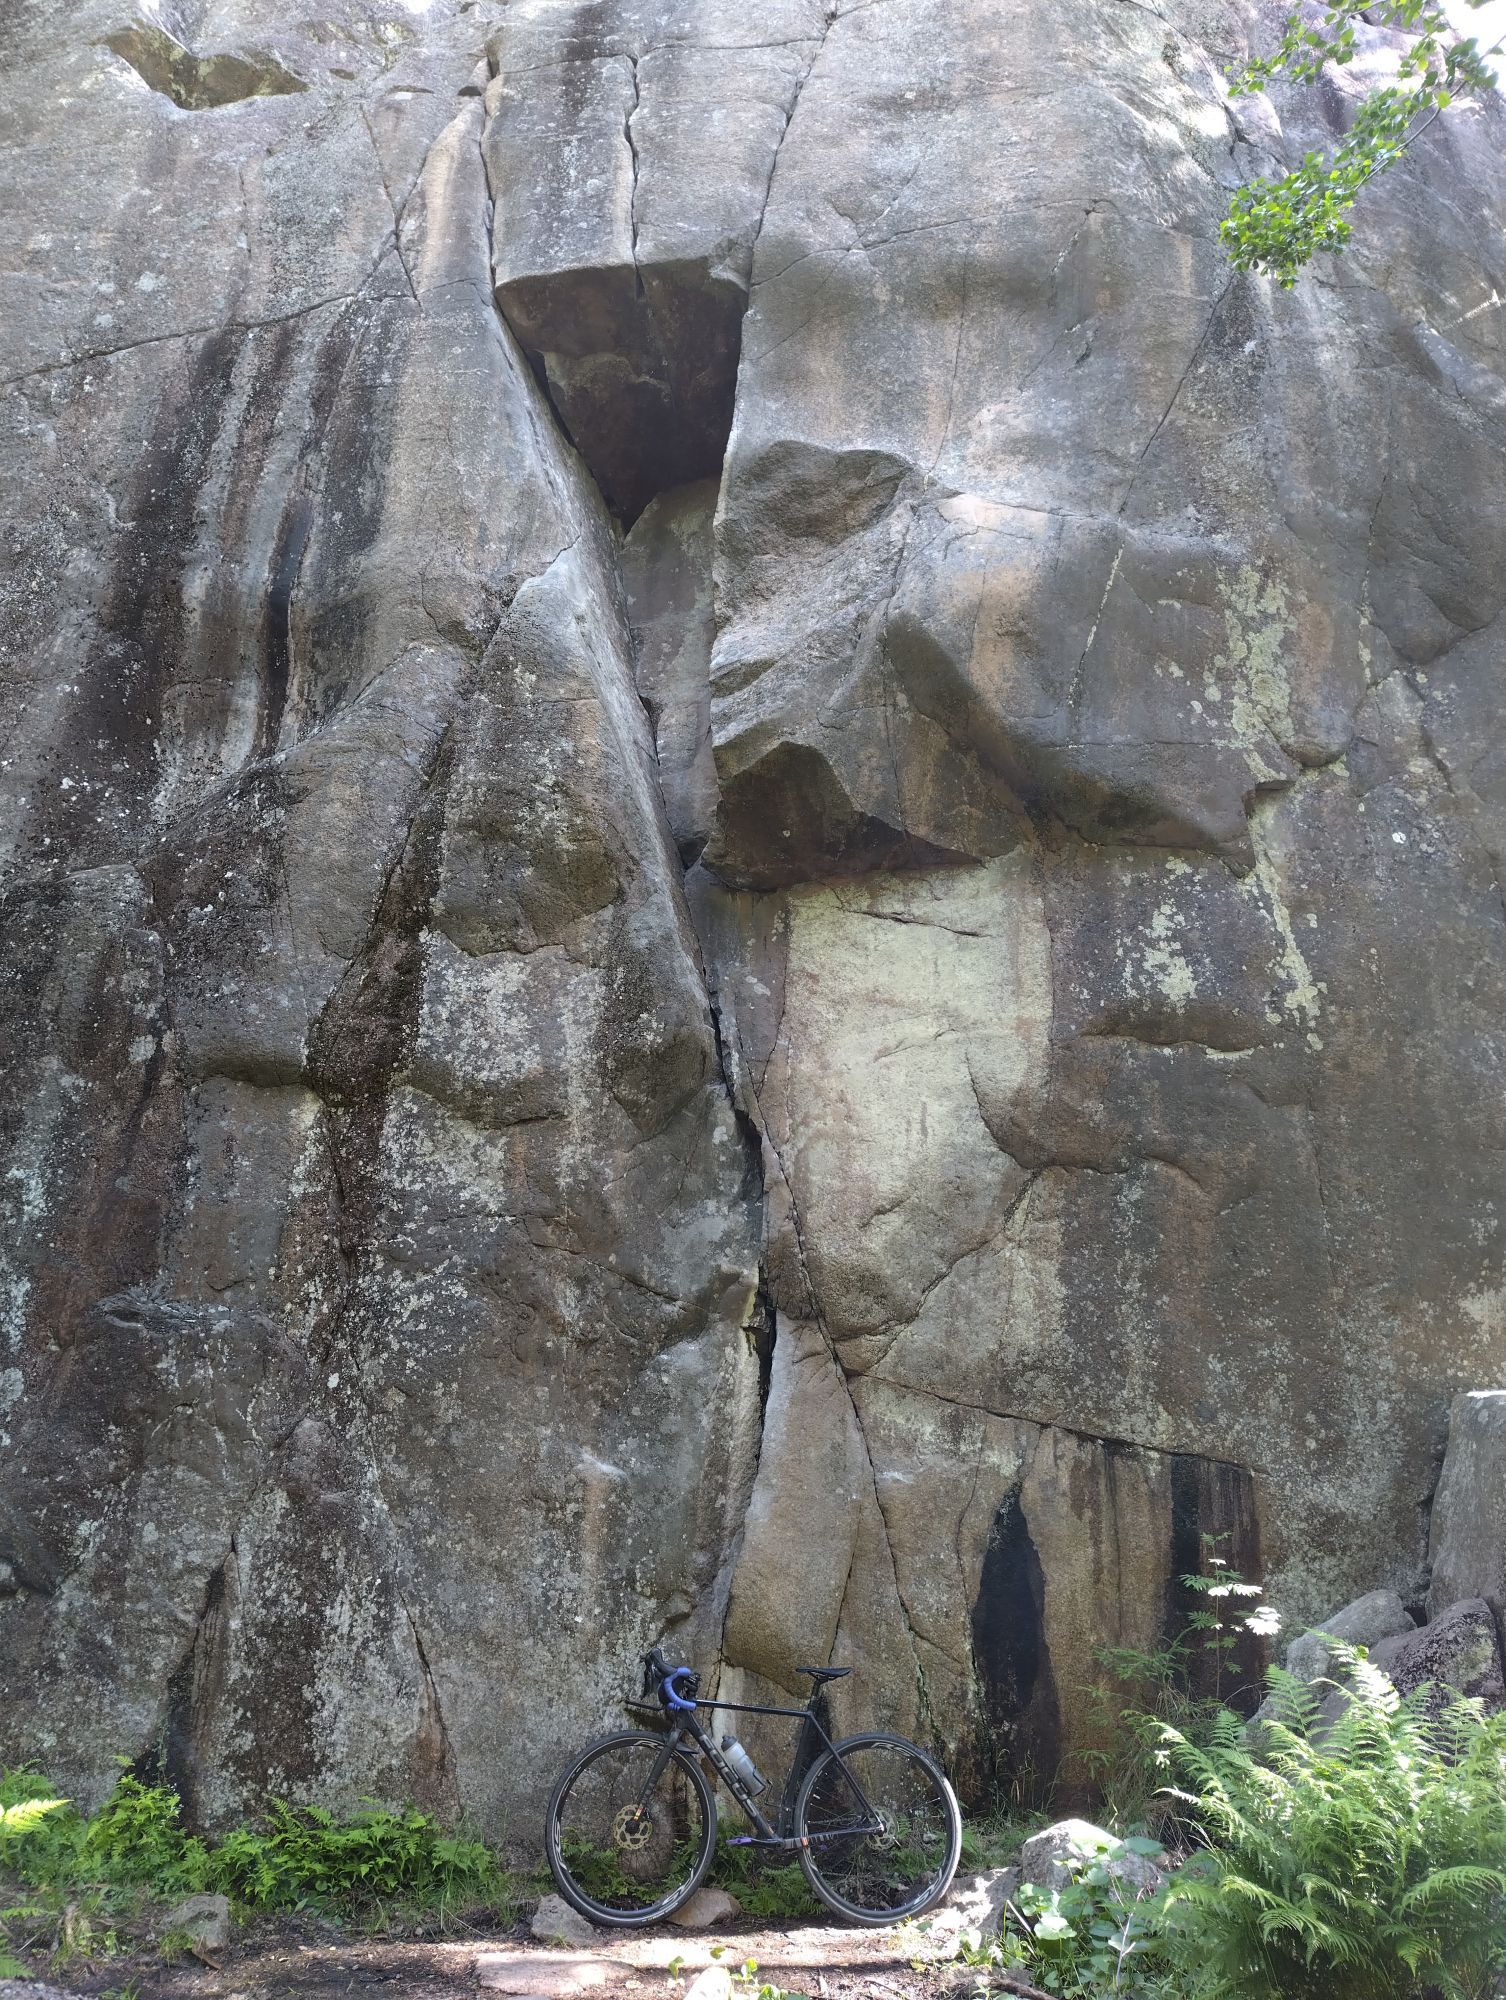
[1220,0,1502,286]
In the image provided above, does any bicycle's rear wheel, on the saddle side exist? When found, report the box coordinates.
[794,1736,962,1924]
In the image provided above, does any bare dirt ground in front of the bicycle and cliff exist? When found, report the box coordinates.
[0,1920,956,2000]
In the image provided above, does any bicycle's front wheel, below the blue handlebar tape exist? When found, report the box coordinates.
[544,1730,716,1924]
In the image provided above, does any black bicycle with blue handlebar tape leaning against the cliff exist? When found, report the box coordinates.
[544,1646,962,1926]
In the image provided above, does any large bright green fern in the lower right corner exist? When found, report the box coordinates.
[1156,1644,1506,2000]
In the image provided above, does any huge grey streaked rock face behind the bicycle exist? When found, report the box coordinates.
[0,0,1506,1844]
